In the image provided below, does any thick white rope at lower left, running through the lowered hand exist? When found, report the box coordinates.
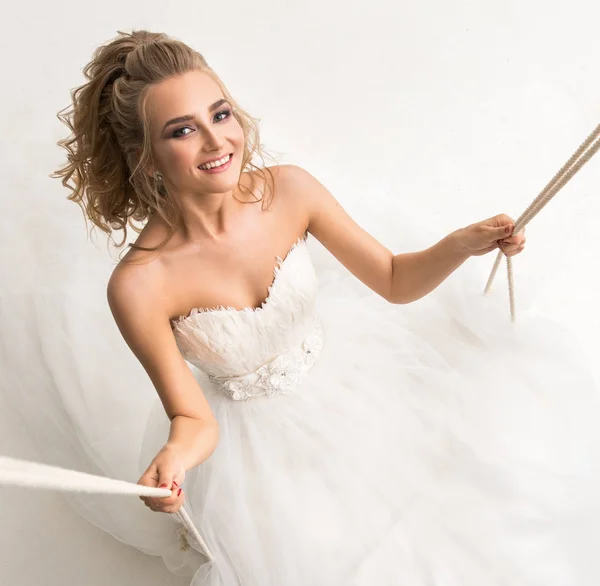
[0,456,213,560]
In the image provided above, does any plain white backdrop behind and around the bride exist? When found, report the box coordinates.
[0,0,600,586]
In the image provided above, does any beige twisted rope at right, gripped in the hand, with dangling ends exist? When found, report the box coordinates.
[484,120,600,322]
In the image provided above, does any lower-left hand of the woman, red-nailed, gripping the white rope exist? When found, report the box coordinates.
[137,446,185,513]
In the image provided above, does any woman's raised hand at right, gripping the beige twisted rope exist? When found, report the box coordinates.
[457,214,526,256]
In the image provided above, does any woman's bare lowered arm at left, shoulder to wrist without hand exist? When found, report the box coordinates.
[107,267,219,470]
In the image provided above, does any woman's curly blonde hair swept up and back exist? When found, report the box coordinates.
[50,30,274,251]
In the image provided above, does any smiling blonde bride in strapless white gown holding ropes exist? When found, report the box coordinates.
[48,31,600,586]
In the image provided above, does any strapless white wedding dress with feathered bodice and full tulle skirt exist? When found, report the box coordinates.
[3,228,600,586]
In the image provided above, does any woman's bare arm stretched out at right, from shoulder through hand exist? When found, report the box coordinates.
[281,165,525,304]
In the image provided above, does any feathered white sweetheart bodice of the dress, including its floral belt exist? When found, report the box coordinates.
[172,238,323,400]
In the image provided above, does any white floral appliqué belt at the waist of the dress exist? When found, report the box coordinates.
[208,317,323,401]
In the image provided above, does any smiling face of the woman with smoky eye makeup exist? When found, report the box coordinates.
[148,71,244,194]
